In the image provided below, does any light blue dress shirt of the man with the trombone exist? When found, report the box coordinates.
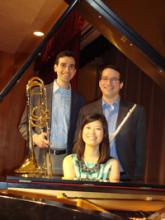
[50,81,71,150]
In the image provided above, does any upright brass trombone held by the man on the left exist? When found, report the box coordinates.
[15,77,53,177]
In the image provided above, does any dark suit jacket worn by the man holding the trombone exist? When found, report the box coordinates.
[19,83,85,153]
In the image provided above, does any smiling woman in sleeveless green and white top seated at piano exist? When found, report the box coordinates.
[63,114,120,182]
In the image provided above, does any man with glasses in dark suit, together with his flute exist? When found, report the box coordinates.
[77,65,146,181]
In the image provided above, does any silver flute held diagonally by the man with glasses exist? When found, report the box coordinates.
[109,104,137,144]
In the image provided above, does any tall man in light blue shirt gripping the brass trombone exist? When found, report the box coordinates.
[19,51,84,175]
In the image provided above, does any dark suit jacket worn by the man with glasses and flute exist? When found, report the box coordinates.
[76,99,146,179]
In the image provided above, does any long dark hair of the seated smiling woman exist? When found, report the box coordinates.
[73,114,110,164]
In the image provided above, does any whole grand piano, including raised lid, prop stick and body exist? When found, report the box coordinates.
[0,0,165,220]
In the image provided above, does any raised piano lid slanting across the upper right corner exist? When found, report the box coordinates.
[77,0,165,89]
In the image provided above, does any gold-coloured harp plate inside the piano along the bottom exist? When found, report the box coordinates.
[8,188,165,211]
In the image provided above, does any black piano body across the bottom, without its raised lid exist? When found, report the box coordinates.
[0,176,165,219]
